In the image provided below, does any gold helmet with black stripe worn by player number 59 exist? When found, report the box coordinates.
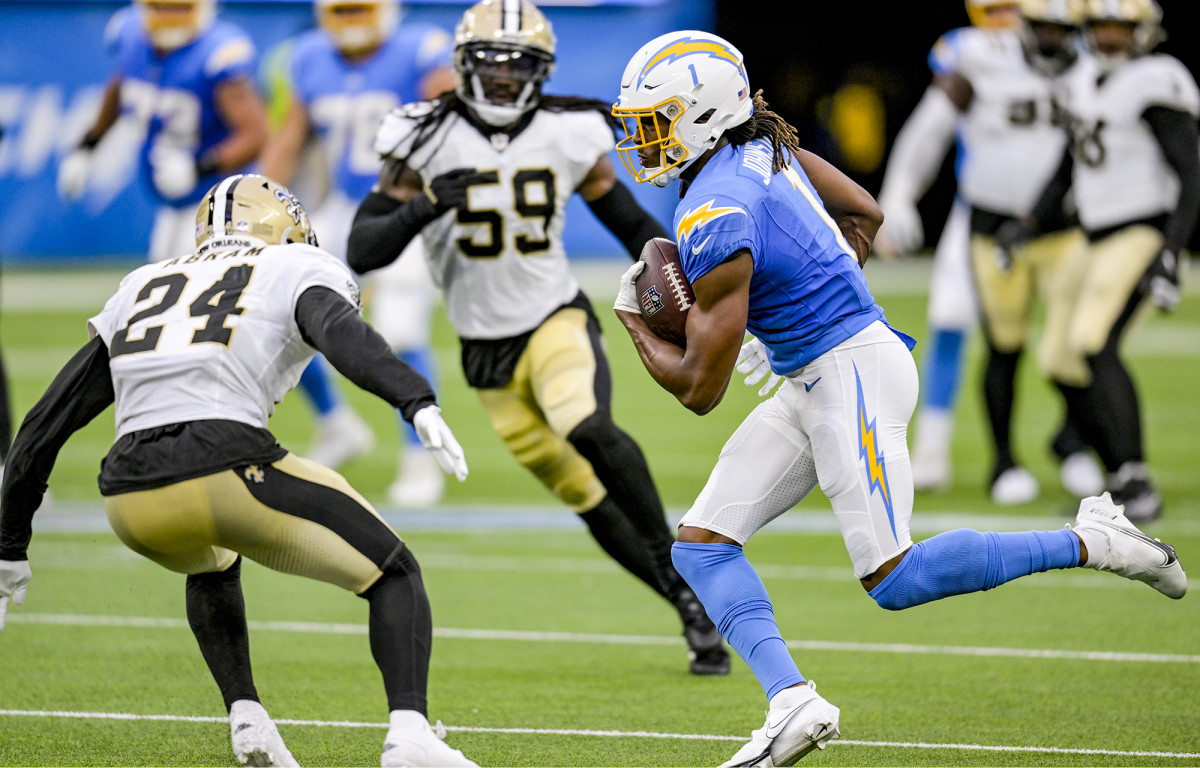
[454,0,556,127]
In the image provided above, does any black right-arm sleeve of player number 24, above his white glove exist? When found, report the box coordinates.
[295,286,437,422]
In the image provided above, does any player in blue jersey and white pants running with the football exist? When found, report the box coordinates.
[613,31,1187,766]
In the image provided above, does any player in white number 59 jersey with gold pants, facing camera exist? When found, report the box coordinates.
[349,0,730,674]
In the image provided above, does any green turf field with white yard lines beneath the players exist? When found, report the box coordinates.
[0,263,1200,766]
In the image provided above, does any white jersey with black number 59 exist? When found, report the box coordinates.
[376,104,614,338]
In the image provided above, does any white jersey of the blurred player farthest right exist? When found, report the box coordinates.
[1064,54,1200,232]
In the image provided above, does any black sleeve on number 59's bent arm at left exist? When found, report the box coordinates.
[346,192,438,275]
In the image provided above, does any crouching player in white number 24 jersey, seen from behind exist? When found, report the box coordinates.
[0,175,475,766]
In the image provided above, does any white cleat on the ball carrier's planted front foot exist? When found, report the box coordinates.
[721,680,841,768]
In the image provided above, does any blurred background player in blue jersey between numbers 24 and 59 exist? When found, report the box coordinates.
[262,0,455,506]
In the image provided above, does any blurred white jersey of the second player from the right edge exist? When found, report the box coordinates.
[930,26,1067,217]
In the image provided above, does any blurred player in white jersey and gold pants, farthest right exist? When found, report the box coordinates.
[1003,0,1200,520]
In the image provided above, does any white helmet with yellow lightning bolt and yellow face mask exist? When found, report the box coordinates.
[612,30,754,187]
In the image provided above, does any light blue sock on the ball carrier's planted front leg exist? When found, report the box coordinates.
[671,541,804,700]
